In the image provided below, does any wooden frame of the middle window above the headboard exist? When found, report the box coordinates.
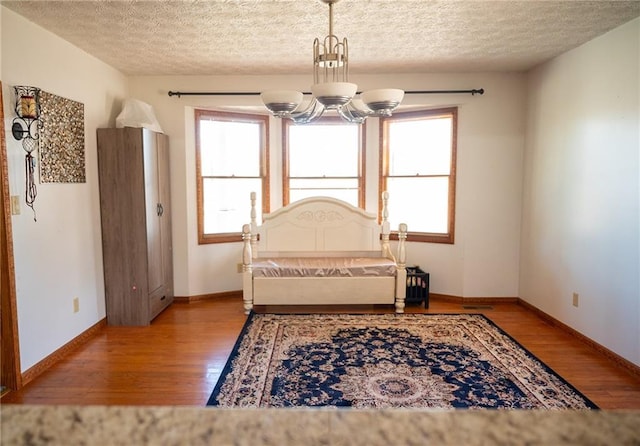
[282,116,367,209]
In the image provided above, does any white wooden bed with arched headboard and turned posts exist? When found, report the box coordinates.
[242,192,407,314]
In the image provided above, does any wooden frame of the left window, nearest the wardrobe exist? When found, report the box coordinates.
[195,109,270,245]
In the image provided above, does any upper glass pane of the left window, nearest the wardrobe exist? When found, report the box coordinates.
[200,120,261,177]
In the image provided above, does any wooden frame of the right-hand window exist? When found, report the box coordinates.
[378,107,458,244]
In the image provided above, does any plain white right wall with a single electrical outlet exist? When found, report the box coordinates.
[520,19,640,365]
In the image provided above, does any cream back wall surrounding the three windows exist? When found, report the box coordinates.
[130,73,525,297]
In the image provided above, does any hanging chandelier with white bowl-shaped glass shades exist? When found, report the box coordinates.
[260,0,404,124]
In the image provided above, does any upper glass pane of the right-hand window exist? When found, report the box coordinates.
[389,117,452,175]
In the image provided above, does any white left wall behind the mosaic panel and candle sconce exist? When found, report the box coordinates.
[0,7,127,371]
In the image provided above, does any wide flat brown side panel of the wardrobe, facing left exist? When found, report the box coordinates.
[97,128,149,325]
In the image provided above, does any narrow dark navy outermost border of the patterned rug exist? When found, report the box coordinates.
[206,311,600,410]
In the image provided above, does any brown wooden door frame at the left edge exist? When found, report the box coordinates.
[0,81,22,390]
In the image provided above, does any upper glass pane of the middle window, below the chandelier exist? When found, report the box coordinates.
[287,124,360,177]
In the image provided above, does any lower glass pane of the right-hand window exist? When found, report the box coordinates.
[387,177,449,234]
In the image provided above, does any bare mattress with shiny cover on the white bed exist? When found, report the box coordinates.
[252,257,397,277]
